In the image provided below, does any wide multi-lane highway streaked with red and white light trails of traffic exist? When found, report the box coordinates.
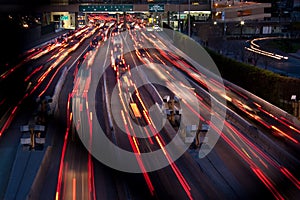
[0,17,300,199]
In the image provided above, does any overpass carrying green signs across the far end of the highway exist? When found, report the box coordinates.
[39,4,211,29]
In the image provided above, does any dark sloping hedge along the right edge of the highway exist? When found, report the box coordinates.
[207,49,300,113]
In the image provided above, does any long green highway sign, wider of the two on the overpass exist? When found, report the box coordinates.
[79,4,133,12]
